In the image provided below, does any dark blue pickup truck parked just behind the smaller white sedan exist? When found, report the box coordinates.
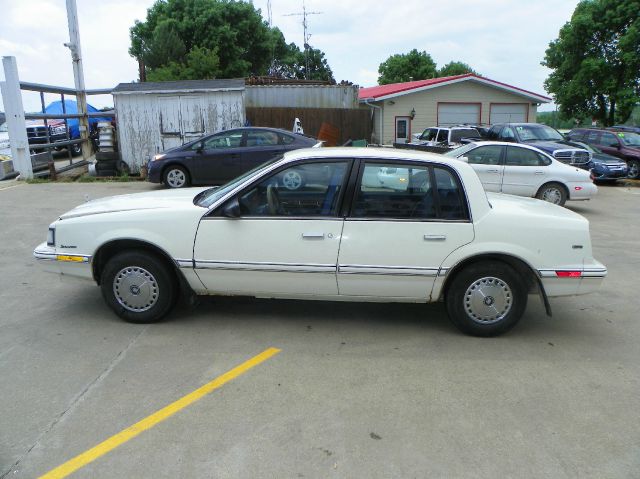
[486,123,591,166]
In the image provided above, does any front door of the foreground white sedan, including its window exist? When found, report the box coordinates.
[194,160,351,297]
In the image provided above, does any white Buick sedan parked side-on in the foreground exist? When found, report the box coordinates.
[34,148,607,336]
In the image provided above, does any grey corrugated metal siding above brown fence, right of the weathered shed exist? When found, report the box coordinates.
[245,85,359,110]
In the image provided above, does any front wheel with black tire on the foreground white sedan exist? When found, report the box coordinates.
[100,250,178,323]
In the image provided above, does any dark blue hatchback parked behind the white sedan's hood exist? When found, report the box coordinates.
[148,127,322,189]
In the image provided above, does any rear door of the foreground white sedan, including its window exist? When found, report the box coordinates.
[338,161,474,301]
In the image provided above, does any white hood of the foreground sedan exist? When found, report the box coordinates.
[60,188,208,220]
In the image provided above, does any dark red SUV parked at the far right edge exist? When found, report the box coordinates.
[567,128,640,179]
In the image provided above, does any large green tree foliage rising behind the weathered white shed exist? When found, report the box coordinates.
[129,0,333,81]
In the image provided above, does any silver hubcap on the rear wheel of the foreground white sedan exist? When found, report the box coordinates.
[464,276,513,324]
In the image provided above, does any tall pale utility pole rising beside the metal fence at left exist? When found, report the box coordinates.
[64,0,91,160]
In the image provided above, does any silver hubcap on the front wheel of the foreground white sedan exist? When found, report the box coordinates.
[113,266,159,313]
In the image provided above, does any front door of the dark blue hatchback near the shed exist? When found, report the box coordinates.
[192,130,246,184]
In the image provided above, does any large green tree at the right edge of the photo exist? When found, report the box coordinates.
[542,0,640,126]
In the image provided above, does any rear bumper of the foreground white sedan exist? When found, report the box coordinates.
[538,260,607,297]
